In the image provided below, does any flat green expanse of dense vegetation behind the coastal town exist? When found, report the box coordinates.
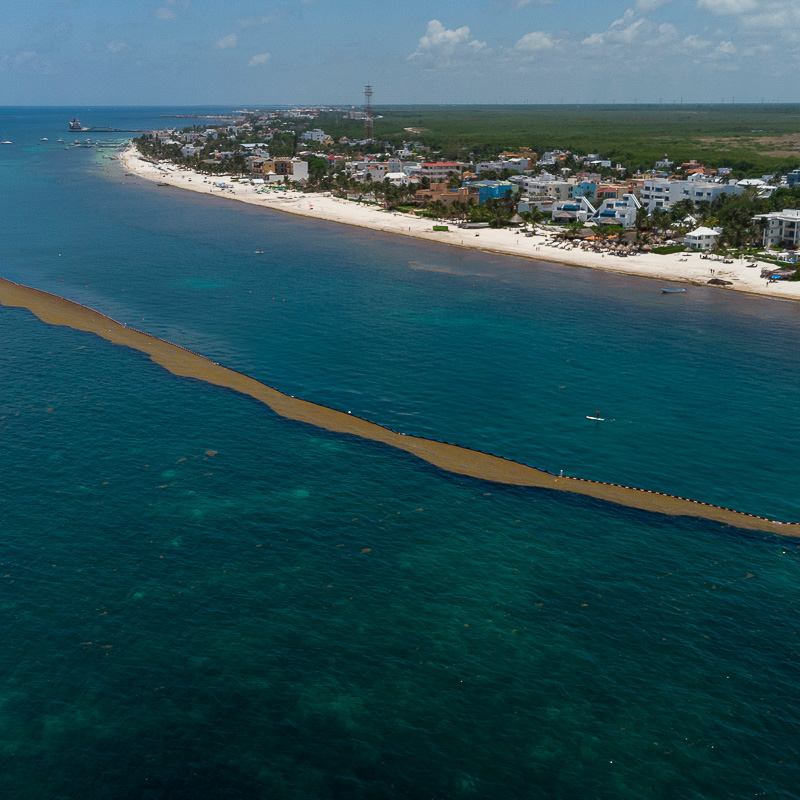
[317,105,800,177]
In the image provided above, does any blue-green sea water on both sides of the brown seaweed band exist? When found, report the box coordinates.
[0,108,800,800]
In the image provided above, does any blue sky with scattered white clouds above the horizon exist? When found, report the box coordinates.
[0,0,800,106]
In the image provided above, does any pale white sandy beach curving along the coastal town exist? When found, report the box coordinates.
[121,145,800,300]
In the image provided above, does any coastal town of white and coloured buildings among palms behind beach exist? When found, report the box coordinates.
[128,106,800,294]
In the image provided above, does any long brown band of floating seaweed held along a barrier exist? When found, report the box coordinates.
[0,278,800,538]
